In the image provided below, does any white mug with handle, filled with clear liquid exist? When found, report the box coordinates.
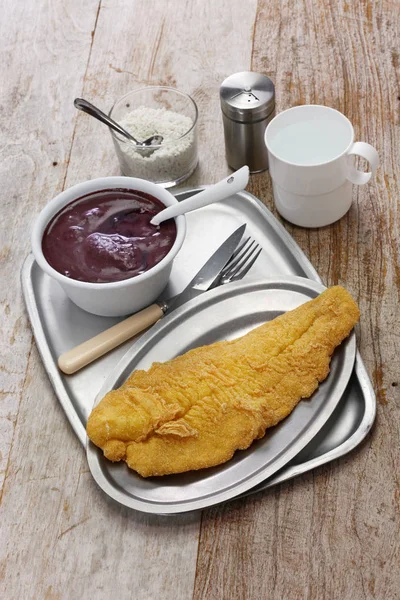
[265,104,379,227]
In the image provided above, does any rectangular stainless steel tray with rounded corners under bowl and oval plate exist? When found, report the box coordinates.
[21,190,376,510]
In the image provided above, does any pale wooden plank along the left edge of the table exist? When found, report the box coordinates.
[0,0,101,493]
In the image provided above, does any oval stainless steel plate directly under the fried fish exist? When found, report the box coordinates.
[87,277,356,514]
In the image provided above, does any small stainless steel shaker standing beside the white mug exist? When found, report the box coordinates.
[220,71,275,173]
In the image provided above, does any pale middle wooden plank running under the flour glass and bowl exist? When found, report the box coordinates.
[0,0,256,600]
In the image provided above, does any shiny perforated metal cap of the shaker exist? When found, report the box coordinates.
[220,71,275,123]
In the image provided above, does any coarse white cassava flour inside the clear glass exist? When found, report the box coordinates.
[114,106,197,183]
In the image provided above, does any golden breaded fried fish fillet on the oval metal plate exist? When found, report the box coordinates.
[87,286,359,477]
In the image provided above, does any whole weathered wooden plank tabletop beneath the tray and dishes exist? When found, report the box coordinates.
[0,0,400,600]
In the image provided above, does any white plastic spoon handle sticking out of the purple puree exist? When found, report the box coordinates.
[150,166,249,225]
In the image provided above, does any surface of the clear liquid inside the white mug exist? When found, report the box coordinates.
[270,119,351,165]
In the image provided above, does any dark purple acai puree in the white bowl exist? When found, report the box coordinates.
[42,189,176,283]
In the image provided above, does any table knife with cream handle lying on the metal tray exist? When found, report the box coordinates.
[58,224,246,375]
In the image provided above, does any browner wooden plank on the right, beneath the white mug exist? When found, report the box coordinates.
[194,0,400,600]
